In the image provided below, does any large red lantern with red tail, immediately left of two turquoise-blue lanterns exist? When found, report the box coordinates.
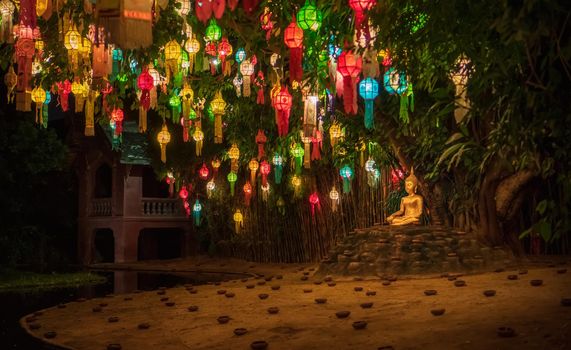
[337,51,363,114]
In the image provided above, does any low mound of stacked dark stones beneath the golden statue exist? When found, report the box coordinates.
[319,225,512,276]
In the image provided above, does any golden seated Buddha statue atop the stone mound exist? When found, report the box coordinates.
[387,168,423,225]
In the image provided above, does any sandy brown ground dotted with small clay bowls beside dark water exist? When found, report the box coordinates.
[21,260,571,350]
